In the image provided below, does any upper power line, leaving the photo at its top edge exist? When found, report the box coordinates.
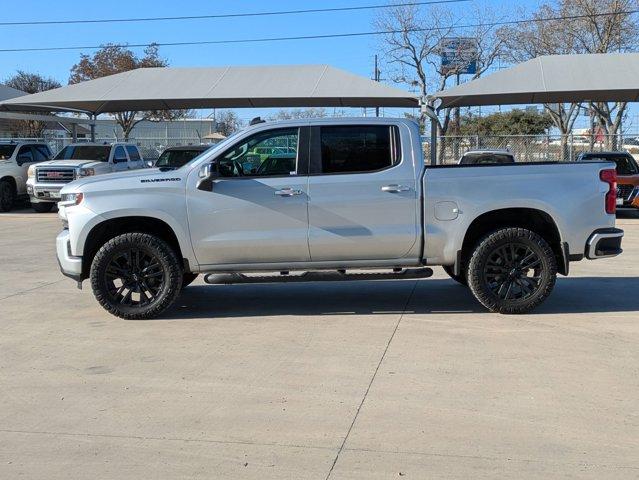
[0,0,471,26]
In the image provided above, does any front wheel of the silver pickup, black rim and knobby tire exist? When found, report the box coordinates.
[91,233,182,320]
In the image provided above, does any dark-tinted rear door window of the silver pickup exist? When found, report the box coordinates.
[320,125,397,173]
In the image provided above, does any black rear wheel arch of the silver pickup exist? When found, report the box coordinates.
[462,207,569,275]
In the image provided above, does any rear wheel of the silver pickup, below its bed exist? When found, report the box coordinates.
[467,228,557,313]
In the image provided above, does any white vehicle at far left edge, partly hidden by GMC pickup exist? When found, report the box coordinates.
[0,142,51,212]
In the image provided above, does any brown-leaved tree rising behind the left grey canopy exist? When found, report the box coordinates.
[69,44,190,140]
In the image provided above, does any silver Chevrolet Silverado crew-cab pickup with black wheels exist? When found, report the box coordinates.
[56,118,623,319]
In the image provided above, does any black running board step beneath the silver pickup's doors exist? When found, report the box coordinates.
[204,268,433,285]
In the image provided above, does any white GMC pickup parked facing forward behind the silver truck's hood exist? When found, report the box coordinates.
[27,142,146,212]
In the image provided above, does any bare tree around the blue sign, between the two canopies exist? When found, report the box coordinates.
[375,5,503,161]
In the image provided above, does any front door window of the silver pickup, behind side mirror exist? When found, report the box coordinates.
[217,128,299,177]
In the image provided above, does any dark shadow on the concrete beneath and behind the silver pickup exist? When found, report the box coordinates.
[158,277,639,320]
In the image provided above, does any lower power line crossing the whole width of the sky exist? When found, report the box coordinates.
[0,9,639,53]
